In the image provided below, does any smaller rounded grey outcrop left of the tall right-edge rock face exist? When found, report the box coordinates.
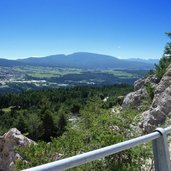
[122,75,158,108]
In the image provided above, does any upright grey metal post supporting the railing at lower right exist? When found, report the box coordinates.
[153,128,171,171]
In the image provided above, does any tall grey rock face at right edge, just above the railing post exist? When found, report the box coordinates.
[140,65,171,133]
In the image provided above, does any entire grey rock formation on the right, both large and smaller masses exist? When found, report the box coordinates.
[122,64,171,133]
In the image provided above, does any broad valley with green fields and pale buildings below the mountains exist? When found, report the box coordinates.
[0,66,147,93]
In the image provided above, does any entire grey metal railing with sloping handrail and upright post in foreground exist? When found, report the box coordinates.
[23,127,171,171]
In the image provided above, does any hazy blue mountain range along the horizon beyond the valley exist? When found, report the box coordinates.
[0,52,156,70]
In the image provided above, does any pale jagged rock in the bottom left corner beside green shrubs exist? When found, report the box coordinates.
[0,128,34,171]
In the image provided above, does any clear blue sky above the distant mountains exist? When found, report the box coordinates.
[0,0,171,59]
